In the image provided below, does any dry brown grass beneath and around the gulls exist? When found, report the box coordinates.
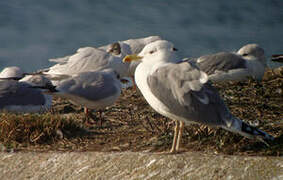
[0,69,283,156]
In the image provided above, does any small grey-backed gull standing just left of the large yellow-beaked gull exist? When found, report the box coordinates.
[45,69,121,124]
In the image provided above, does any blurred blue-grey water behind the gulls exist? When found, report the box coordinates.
[0,0,283,72]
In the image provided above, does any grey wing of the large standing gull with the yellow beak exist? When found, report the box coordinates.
[147,62,232,126]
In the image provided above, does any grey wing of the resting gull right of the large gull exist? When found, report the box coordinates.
[197,52,246,75]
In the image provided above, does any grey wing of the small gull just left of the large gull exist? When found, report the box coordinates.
[57,72,121,101]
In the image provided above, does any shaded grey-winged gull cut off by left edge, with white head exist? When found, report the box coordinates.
[0,75,52,113]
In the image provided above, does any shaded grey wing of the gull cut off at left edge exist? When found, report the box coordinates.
[0,82,45,108]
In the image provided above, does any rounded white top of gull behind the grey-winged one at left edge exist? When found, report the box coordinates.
[0,66,25,80]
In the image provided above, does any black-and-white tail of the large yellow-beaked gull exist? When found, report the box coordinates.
[223,117,274,145]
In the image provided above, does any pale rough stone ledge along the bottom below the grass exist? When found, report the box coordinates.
[0,152,283,180]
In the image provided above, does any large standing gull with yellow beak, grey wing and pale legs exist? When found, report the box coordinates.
[123,40,273,153]
